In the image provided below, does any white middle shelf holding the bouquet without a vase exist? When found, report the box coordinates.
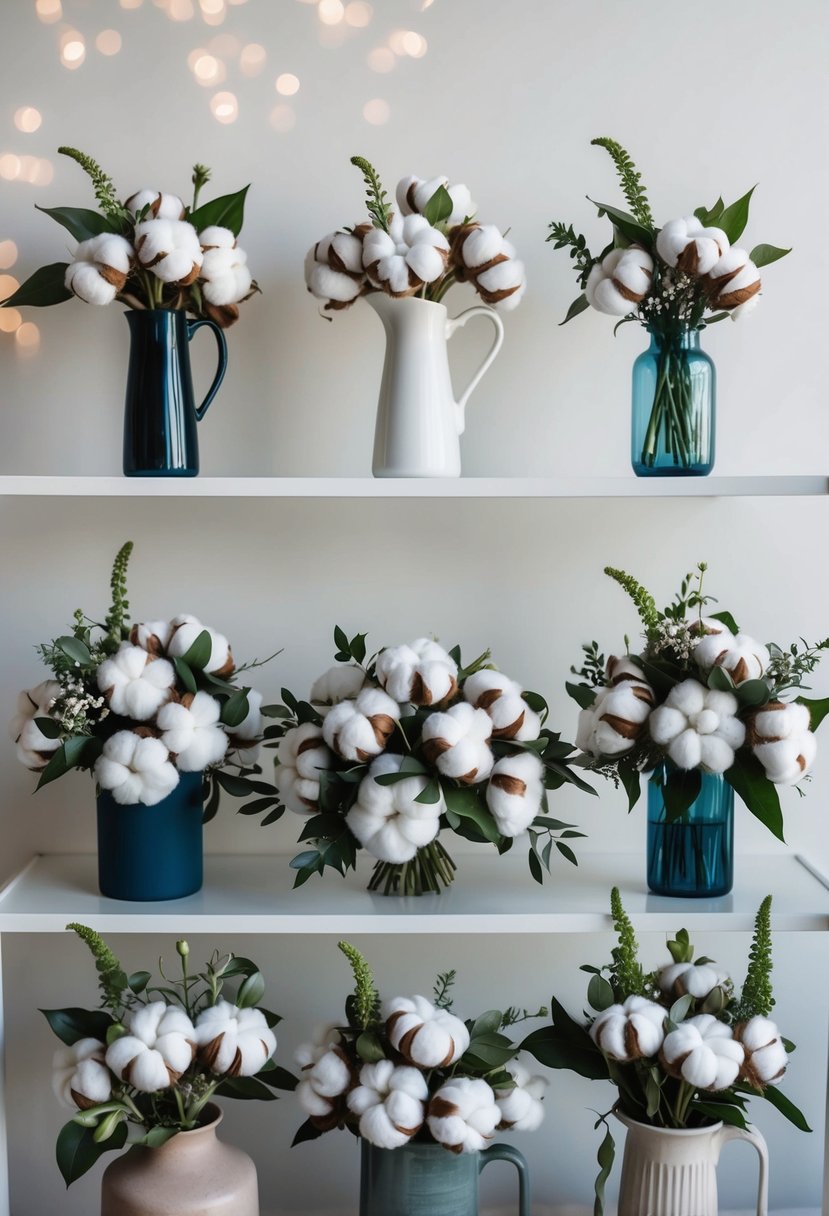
[0,851,829,935]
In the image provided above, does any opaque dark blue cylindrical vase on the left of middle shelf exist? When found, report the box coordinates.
[97,772,203,902]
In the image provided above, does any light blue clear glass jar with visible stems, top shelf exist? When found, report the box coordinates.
[631,330,717,477]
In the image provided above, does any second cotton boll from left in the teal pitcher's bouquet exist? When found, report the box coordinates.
[348,1060,429,1148]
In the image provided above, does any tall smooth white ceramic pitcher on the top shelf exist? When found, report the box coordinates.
[366,292,503,477]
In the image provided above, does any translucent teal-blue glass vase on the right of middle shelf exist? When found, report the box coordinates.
[648,765,734,899]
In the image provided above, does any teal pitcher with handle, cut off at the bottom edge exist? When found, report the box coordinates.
[360,1141,530,1216]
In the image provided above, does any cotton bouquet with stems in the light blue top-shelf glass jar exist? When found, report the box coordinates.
[547,137,791,466]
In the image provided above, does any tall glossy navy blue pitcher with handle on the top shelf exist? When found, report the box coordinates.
[124,309,227,477]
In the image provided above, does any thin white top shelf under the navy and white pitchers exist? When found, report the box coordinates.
[0,475,829,499]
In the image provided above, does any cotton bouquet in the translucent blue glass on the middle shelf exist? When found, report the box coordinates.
[566,562,829,840]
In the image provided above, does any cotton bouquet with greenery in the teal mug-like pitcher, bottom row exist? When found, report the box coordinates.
[294,941,547,1153]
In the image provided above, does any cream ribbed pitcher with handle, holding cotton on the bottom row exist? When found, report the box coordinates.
[616,1111,768,1216]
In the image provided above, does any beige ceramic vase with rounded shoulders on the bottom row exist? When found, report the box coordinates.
[101,1105,259,1216]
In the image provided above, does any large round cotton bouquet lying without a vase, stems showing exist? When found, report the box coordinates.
[250,627,594,895]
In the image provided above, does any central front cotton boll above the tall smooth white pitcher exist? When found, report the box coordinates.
[362,214,449,297]
